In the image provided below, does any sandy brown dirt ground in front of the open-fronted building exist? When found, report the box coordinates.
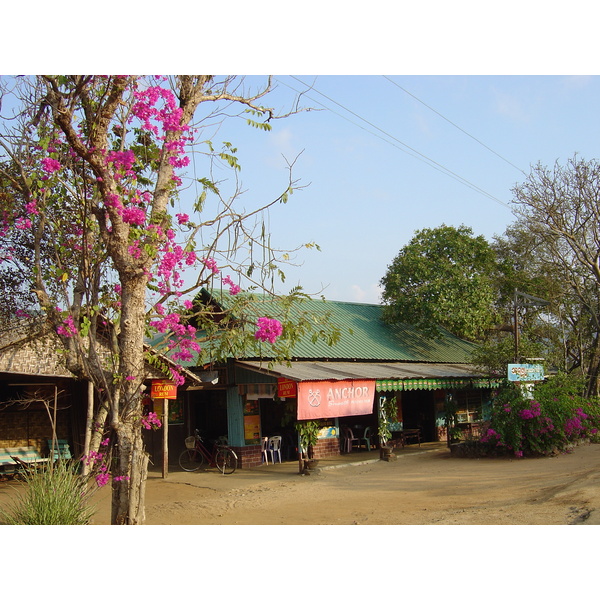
[23,444,600,525]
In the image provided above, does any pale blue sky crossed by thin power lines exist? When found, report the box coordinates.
[186,75,600,303]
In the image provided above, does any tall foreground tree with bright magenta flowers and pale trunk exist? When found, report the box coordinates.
[0,75,335,524]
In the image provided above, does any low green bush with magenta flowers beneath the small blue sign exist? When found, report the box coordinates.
[480,375,600,457]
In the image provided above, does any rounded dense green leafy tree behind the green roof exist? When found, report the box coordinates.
[381,225,494,340]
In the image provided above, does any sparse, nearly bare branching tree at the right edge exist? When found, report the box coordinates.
[513,156,600,395]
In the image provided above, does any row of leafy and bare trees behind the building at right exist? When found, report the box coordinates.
[381,156,600,396]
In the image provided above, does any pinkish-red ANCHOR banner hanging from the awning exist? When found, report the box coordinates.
[298,379,375,421]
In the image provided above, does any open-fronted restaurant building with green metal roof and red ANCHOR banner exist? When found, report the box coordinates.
[157,294,498,468]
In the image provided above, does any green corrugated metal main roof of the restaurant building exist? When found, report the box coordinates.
[206,292,475,363]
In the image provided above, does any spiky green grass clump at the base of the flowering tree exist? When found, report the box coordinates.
[0,461,95,525]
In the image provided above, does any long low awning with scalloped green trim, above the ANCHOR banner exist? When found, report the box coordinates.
[236,360,500,392]
